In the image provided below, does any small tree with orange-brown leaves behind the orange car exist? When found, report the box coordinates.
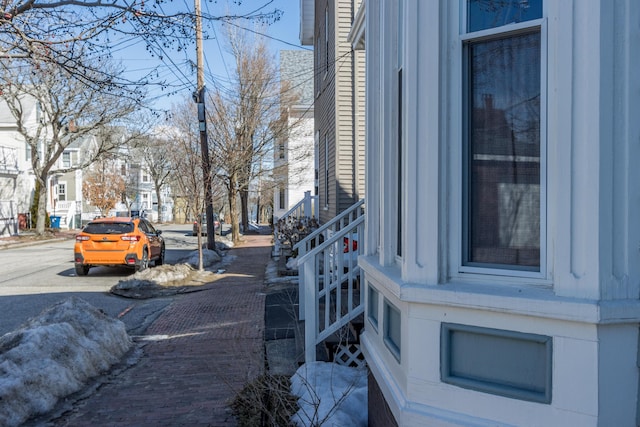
[82,159,125,216]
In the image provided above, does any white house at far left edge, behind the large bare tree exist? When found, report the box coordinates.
[0,99,38,236]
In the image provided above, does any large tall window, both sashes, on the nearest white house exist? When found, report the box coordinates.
[462,0,545,271]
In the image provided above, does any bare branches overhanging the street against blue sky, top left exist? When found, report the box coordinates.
[0,0,282,102]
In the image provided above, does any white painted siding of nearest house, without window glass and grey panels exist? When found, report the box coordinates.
[360,0,640,426]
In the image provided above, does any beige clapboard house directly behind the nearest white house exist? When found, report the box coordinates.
[300,0,365,223]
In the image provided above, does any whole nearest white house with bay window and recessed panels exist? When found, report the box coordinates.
[351,0,640,426]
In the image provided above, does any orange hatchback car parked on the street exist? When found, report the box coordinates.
[73,217,165,276]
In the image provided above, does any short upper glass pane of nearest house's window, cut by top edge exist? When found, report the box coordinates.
[467,0,542,32]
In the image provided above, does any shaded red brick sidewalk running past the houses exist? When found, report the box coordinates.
[56,235,271,427]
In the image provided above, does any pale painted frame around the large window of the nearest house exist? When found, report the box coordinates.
[450,10,550,284]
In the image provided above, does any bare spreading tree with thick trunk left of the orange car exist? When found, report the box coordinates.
[0,45,142,234]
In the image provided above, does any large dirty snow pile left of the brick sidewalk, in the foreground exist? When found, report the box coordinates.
[0,297,132,426]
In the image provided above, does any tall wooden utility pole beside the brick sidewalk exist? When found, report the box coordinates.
[194,0,216,250]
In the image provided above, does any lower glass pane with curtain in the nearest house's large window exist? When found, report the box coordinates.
[465,32,540,271]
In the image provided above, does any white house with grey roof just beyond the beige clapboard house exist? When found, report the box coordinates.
[273,50,316,219]
